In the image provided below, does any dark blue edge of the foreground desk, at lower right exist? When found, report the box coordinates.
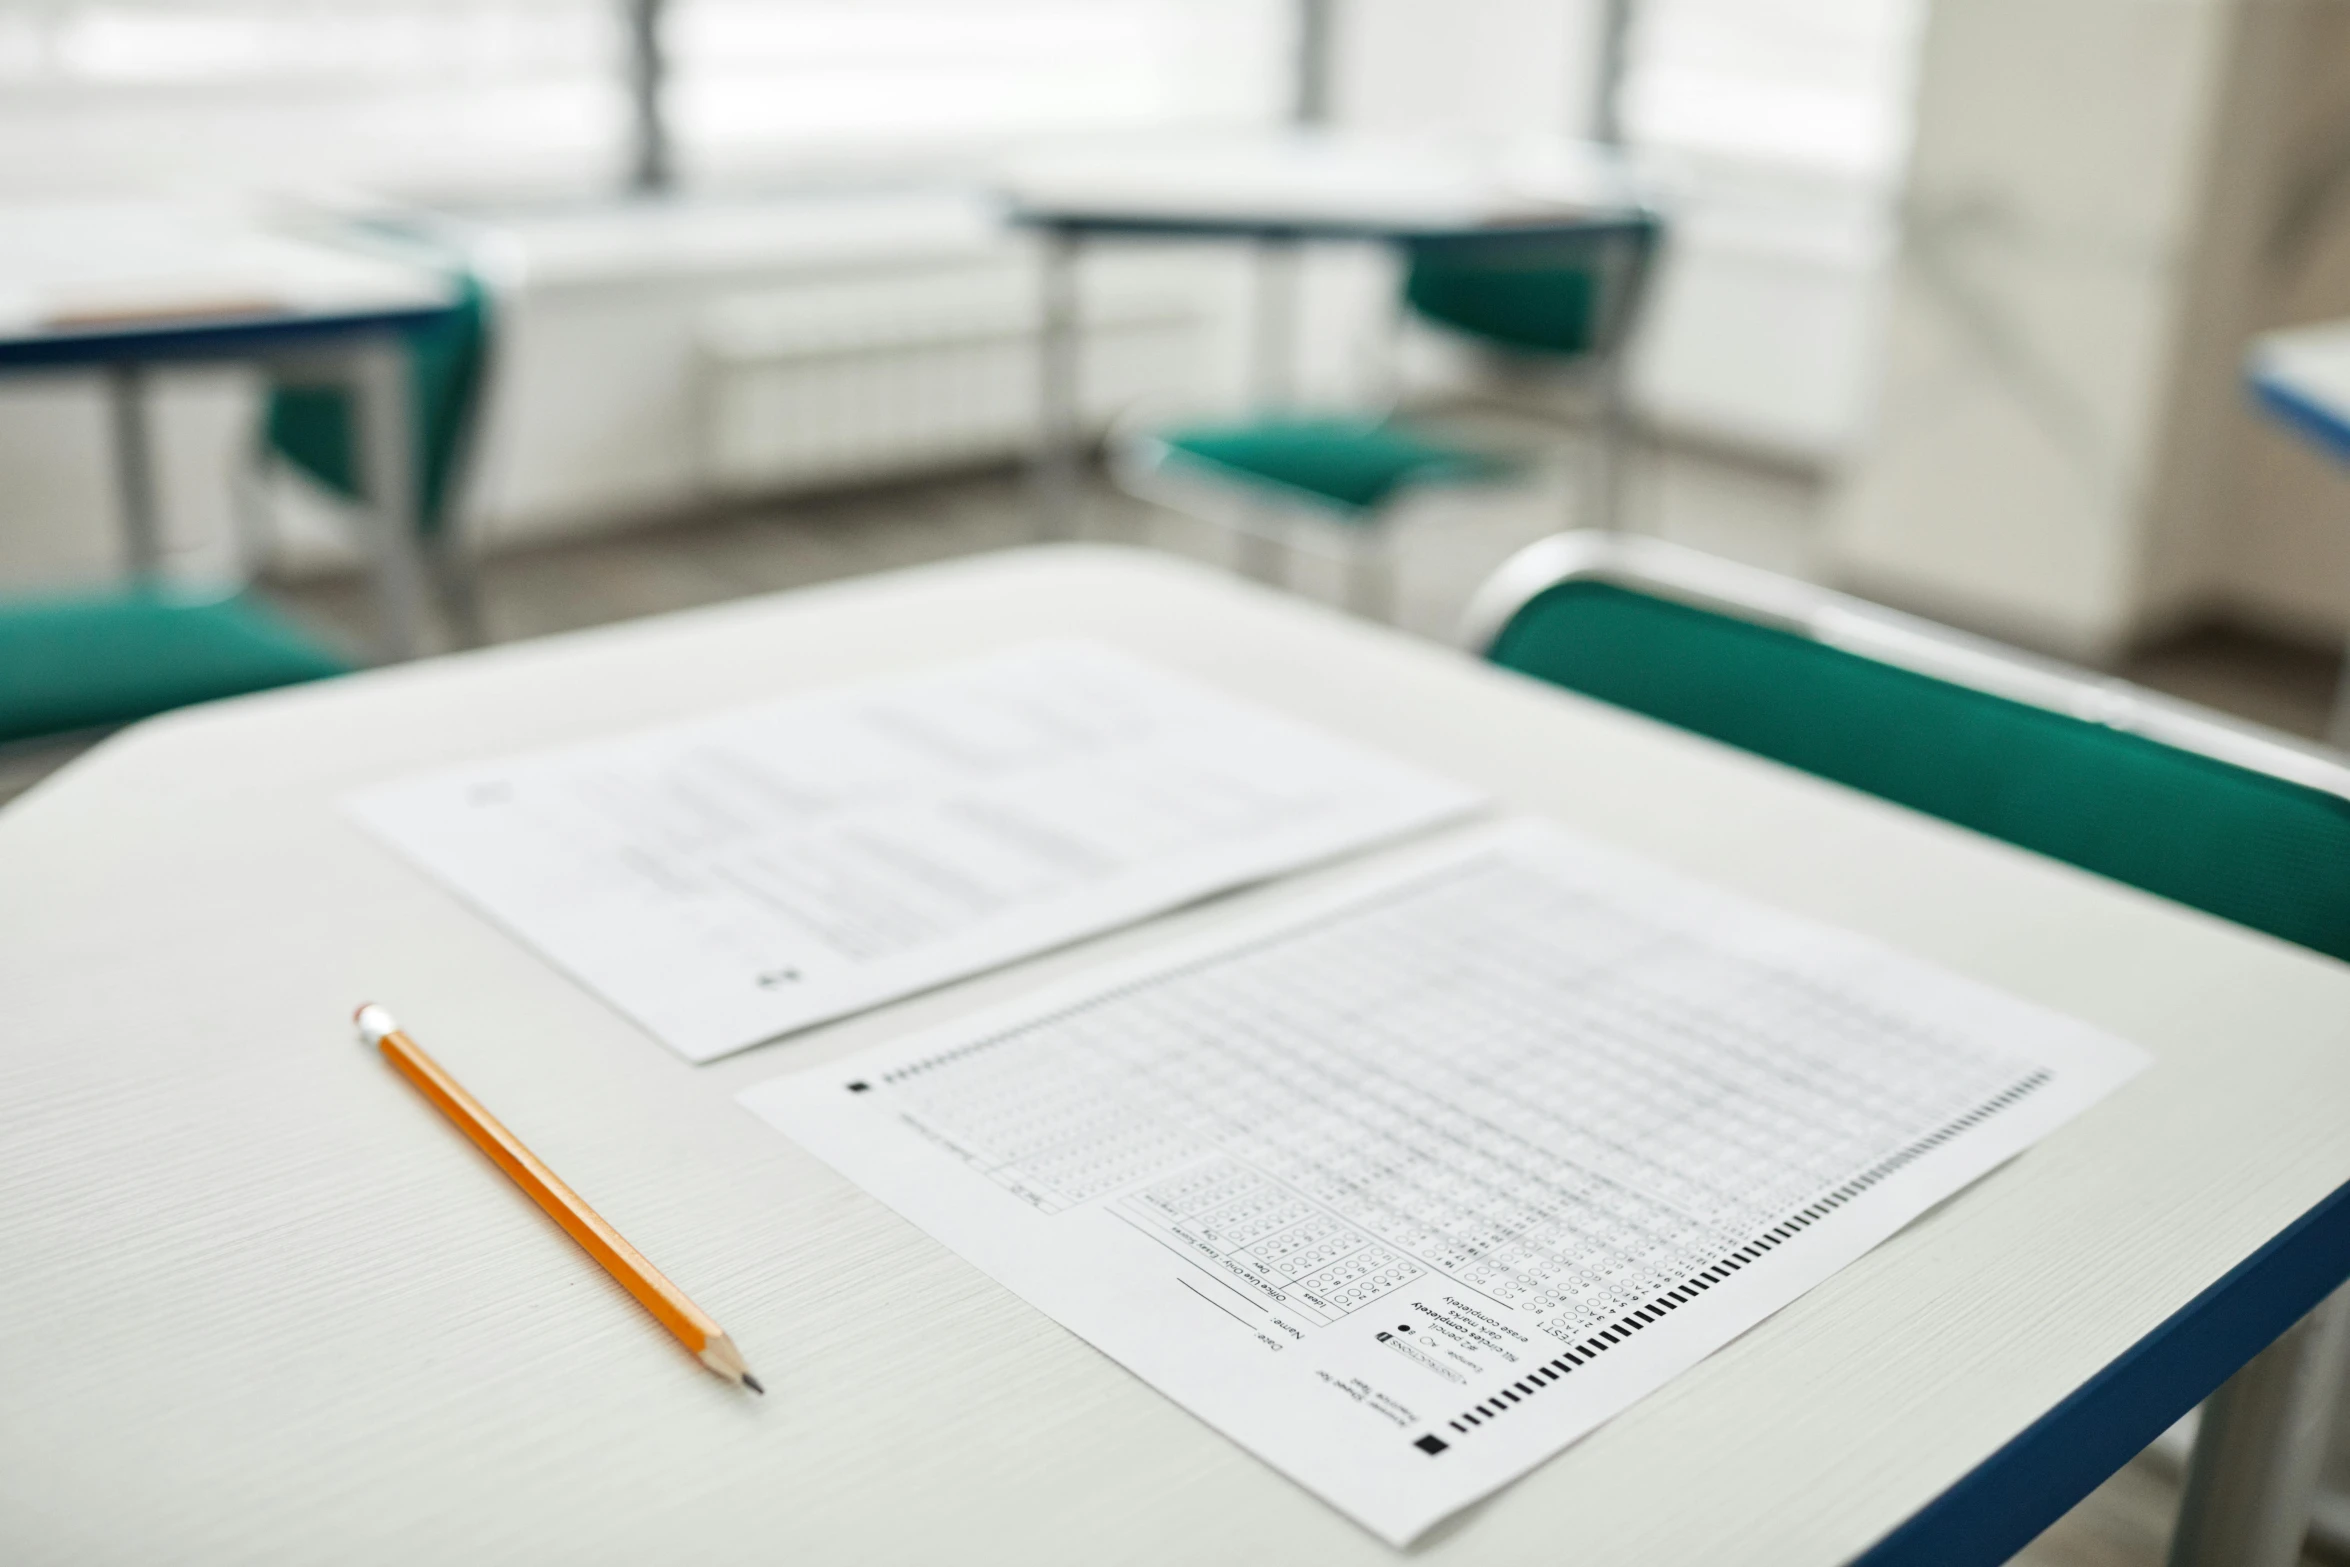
[1854,1186,2350,1567]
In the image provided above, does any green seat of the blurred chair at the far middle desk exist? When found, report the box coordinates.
[1159,418,1509,519]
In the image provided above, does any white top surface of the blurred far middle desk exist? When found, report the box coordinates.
[1001,132,1645,233]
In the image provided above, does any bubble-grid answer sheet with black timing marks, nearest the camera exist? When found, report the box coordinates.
[743,825,2143,1558]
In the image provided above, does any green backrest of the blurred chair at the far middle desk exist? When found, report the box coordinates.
[1403,228,1657,357]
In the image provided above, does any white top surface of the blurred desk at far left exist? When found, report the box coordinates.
[0,200,449,336]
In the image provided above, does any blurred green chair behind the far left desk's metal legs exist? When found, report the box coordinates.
[256,254,491,644]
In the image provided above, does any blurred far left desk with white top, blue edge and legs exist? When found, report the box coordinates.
[0,202,451,658]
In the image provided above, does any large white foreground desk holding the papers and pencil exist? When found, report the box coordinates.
[0,547,2350,1567]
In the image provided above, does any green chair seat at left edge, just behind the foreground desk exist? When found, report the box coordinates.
[0,590,350,742]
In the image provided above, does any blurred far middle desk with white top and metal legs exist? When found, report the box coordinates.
[1001,142,1657,538]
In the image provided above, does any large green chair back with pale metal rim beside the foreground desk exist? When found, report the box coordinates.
[1464,533,2350,959]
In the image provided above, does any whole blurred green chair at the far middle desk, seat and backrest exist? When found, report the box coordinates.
[1112,221,1659,613]
